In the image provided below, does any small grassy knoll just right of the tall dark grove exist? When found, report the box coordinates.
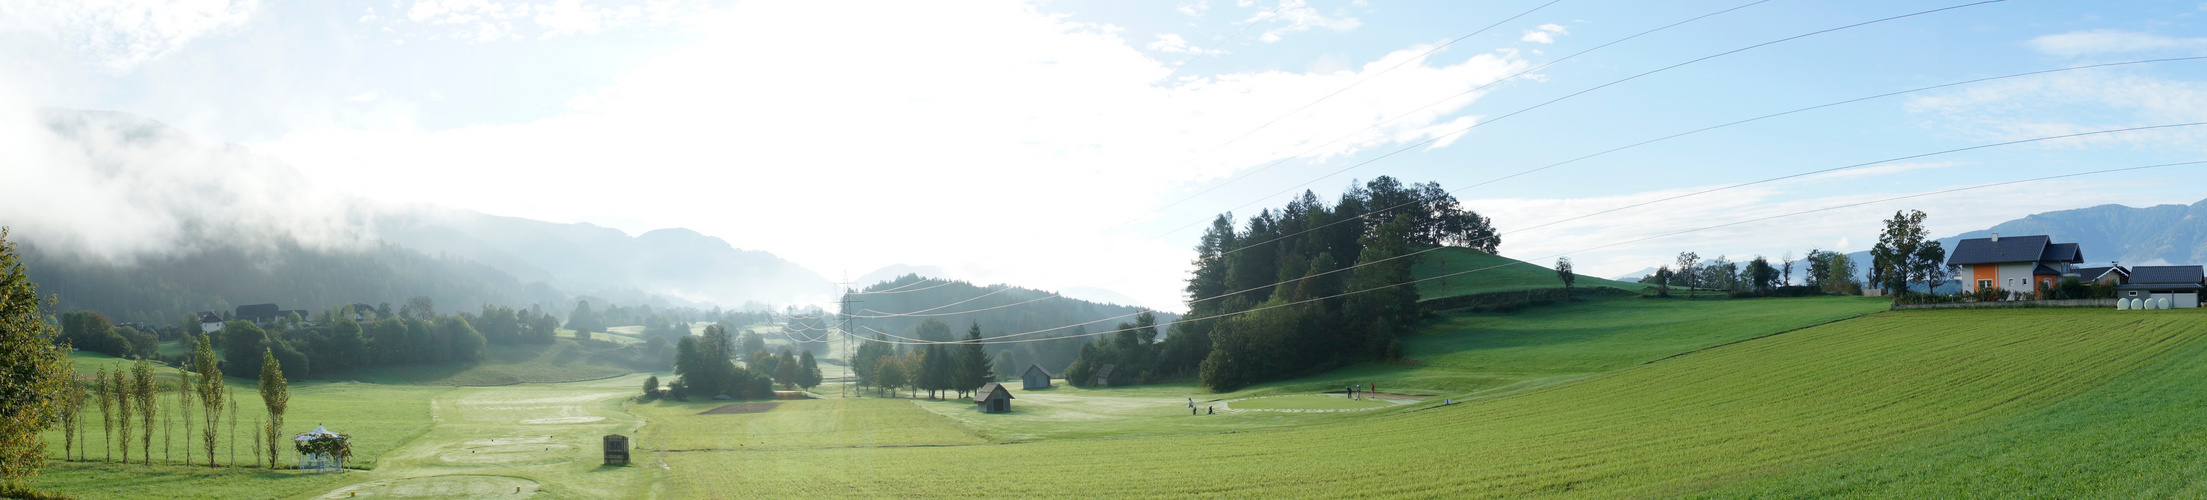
[1410,247,1644,300]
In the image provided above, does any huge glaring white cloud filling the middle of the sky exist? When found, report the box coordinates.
[256,2,1525,304]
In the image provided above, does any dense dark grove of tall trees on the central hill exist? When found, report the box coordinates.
[1174,176,1501,390]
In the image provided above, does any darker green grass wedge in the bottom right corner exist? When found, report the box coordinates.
[1704,311,2207,498]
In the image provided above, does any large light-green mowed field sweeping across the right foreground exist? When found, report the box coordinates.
[644,311,2207,498]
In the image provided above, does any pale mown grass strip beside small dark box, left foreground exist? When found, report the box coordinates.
[320,374,655,498]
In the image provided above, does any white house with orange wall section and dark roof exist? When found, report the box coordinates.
[1947,233,2083,293]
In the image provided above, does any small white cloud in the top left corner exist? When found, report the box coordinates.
[0,0,258,73]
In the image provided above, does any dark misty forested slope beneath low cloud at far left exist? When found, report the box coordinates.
[22,242,567,324]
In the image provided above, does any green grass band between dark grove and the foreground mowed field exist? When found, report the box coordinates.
[909,297,1887,441]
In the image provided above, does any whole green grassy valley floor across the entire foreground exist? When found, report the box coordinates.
[33,297,2207,498]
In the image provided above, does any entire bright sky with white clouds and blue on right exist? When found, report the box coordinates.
[0,0,2207,311]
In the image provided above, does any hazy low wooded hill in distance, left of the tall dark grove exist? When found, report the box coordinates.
[852,273,1181,370]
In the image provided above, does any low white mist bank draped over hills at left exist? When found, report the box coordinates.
[4,108,830,319]
